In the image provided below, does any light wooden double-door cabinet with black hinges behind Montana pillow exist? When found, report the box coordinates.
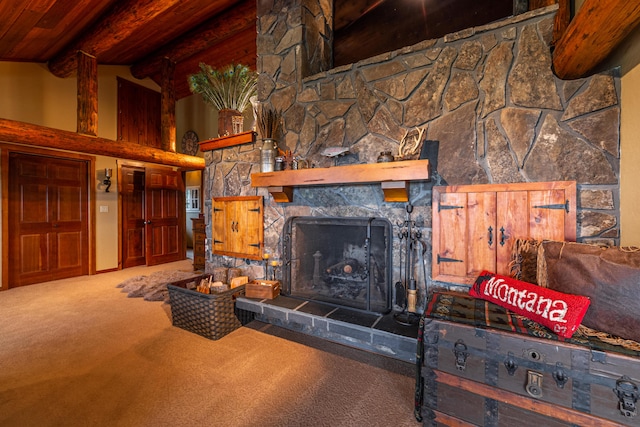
[431,182,576,284]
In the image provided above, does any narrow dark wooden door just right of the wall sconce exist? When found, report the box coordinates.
[120,166,147,268]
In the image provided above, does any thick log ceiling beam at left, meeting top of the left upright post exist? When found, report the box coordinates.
[49,0,181,78]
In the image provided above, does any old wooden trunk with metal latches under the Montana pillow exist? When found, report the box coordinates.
[417,294,640,427]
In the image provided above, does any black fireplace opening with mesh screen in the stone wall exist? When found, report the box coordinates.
[282,217,393,313]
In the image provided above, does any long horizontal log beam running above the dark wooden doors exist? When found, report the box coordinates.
[0,119,205,170]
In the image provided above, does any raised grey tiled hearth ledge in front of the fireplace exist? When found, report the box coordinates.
[236,295,418,363]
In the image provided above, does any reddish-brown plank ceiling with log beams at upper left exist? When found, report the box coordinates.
[0,0,256,99]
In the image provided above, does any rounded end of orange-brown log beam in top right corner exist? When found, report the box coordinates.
[553,0,640,80]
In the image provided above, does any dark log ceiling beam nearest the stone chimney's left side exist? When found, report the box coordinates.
[131,0,257,79]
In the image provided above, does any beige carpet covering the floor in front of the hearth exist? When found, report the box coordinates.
[0,260,419,426]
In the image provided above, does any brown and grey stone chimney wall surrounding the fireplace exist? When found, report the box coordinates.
[205,0,620,306]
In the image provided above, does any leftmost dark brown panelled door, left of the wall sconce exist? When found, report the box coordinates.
[8,153,89,288]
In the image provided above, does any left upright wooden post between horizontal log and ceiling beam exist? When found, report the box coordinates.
[77,50,98,136]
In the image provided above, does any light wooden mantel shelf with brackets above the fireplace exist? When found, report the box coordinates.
[251,160,431,203]
